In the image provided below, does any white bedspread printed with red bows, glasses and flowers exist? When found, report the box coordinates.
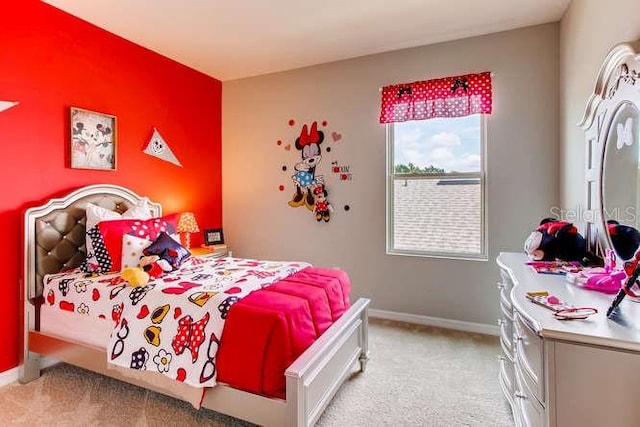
[44,257,309,387]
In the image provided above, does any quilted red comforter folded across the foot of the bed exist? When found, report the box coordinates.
[217,267,351,398]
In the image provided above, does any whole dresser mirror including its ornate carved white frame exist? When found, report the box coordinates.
[578,41,640,266]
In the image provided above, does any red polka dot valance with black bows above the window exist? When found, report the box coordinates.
[380,72,491,123]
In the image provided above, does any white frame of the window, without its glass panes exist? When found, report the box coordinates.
[385,114,488,261]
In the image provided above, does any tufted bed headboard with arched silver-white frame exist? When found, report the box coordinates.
[23,184,162,303]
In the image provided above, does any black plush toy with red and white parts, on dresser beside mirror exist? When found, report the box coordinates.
[524,218,587,261]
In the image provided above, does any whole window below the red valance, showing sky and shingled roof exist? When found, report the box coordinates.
[387,114,487,260]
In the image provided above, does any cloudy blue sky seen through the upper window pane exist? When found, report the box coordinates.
[394,114,481,172]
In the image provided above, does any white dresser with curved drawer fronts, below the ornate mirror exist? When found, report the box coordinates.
[497,253,640,427]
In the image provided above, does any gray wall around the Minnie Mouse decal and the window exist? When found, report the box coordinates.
[222,24,559,325]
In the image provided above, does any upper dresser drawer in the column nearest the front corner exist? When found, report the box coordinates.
[514,313,545,403]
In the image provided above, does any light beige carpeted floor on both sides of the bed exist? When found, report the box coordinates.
[0,319,513,427]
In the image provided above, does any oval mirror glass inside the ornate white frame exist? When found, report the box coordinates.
[601,102,640,260]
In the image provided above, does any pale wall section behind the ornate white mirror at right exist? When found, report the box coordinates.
[560,0,640,217]
